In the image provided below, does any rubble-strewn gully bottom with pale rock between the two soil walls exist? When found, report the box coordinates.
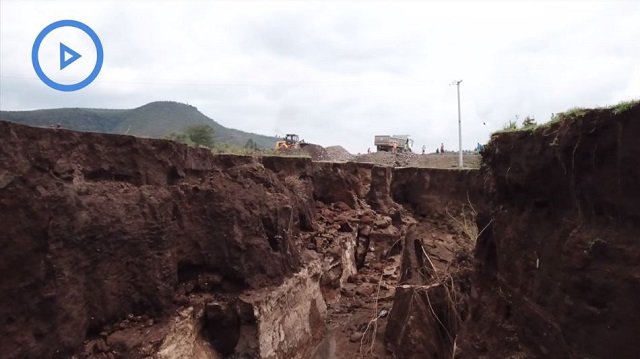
[69,164,475,358]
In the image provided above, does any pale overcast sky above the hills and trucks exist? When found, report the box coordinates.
[0,0,640,153]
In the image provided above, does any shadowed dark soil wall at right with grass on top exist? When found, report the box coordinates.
[458,104,640,358]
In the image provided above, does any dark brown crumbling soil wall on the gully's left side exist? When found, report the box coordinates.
[0,122,312,358]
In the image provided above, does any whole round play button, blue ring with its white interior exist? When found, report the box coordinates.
[31,20,104,91]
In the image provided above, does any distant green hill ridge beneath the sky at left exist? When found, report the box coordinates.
[0,101,277,148]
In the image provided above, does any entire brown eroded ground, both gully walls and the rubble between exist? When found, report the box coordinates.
[0,101,640,358]
